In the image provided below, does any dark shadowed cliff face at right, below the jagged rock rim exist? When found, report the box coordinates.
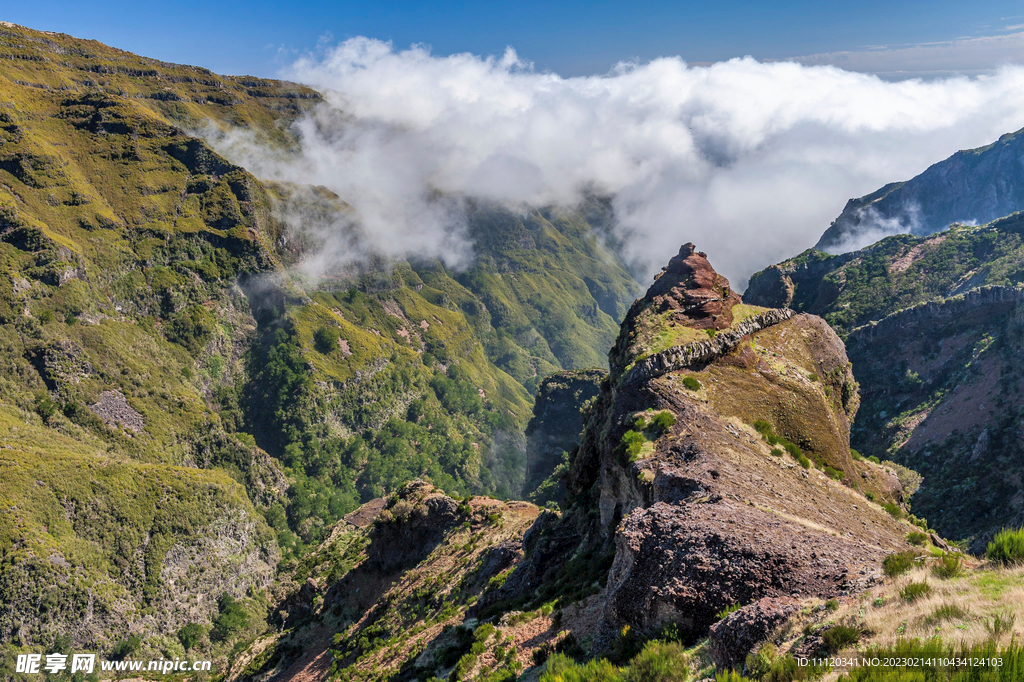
[848,287,1024,552]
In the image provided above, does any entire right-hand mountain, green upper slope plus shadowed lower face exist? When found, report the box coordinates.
[744,213,1024,552]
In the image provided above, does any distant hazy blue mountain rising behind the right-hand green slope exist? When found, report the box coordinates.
[814,125,1024,252]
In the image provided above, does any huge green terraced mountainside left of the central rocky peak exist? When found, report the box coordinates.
[0,24,637,662]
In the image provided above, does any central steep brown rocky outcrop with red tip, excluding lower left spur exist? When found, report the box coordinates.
[504,245,906,643]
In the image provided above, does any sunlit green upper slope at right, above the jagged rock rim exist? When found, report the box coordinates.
[743,213,1024,335]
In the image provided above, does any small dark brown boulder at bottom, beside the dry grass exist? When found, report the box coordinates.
[708,597,800,670]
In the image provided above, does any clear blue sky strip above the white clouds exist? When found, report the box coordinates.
[8,0,1024,76]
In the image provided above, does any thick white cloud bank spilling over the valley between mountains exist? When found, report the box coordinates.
[203,38,1024,288]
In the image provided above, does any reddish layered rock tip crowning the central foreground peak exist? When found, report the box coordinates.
[642,243,739,329]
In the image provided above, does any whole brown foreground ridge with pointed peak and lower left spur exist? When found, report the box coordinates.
[247,245,983,682]
